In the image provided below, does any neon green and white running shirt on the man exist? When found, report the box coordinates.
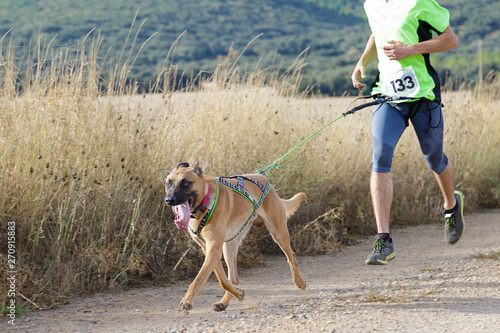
[364,0,450,101]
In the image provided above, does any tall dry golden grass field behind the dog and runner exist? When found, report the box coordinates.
[0,33,500,308]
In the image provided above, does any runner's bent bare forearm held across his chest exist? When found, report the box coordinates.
[381,26,458,60]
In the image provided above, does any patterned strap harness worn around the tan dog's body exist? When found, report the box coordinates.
[189,175,271,242]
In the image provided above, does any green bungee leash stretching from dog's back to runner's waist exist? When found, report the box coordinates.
[254,94,418,175]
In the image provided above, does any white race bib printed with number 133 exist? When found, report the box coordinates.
[380,66,420,97]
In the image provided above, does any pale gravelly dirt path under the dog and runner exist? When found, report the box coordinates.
[4,210,500,333]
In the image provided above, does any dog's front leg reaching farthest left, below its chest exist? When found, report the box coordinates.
[179,242,222,311]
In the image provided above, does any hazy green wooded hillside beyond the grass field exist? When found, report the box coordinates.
[0,0,500,95]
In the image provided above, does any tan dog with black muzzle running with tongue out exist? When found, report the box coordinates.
[165,162,307,311]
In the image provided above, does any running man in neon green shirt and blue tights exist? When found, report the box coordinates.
[351,0,465,265]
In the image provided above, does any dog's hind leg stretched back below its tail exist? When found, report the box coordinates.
[265,210,306,289]
